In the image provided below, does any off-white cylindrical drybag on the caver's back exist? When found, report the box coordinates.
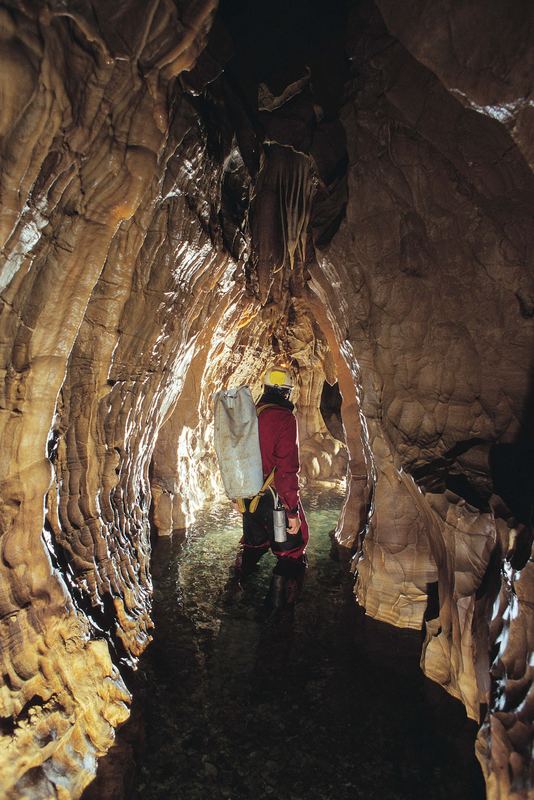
[213,386,263,499]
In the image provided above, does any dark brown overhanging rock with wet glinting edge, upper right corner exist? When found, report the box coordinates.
[376,0,534,173]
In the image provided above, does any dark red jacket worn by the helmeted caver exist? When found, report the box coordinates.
[258,402,300,517]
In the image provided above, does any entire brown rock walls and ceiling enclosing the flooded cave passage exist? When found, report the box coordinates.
[0,0,534,798]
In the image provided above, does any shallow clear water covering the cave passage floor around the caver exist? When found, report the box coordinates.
[129,492,484,800]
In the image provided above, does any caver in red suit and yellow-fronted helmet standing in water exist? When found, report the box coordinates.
[233,367,308,610]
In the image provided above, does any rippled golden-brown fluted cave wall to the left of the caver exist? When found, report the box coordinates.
[0,3,233,797]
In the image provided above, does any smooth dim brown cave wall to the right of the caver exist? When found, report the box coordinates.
[314,3,534,797]
